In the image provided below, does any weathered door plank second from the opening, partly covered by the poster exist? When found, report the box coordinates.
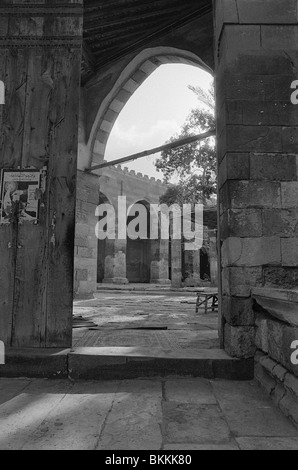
[12,50,49,347]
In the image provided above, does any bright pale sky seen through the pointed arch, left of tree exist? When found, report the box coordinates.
[105,64,212,179]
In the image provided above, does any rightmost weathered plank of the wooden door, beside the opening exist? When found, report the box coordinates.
[47,50,81,347]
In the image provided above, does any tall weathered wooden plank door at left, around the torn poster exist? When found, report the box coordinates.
[0,0,83,347]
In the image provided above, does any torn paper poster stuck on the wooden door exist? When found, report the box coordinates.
[0,169,41,224]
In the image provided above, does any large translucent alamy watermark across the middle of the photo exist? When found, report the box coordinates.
[95,196,204,251]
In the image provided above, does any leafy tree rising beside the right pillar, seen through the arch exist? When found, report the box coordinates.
[155,86,216,204]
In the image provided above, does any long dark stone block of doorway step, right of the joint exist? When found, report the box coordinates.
[69,347,253,380]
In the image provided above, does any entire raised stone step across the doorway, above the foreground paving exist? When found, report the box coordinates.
[0,347,254,380]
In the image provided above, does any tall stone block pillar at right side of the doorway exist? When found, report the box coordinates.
[214,0,298,357]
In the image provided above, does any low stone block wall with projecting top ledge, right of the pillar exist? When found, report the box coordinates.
[254,289,298,427]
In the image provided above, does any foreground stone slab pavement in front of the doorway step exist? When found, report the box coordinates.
[0,377,298,451]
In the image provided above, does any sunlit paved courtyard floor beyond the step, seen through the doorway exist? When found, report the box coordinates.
[73,289,219,351]
